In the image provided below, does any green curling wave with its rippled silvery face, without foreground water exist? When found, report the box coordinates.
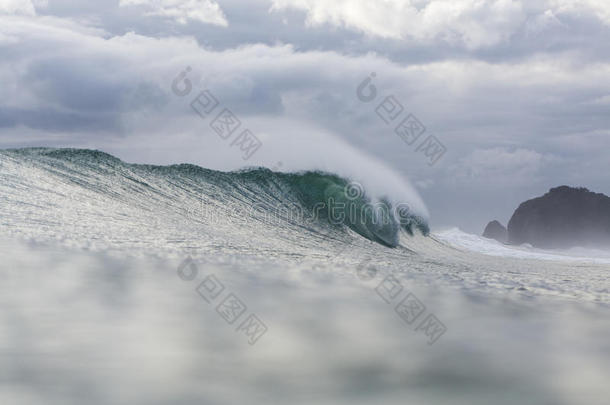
[0,148,429,251]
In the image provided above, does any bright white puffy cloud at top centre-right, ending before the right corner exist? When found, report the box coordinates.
[272,0,526,48]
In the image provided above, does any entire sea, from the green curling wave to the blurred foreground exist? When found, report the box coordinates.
[0,148,610,404]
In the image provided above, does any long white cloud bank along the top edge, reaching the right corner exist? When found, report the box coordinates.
[271,0,610,50]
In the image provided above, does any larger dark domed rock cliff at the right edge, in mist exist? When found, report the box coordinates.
[508,186,610,248]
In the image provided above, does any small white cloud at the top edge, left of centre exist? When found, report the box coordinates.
[119,0,228,27]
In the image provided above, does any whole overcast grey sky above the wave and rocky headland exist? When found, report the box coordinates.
[0,0,610,233]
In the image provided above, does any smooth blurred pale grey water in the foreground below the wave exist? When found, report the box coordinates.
[0,240,610,405]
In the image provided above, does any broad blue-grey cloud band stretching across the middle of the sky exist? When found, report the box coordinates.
[0,17,610,161]
